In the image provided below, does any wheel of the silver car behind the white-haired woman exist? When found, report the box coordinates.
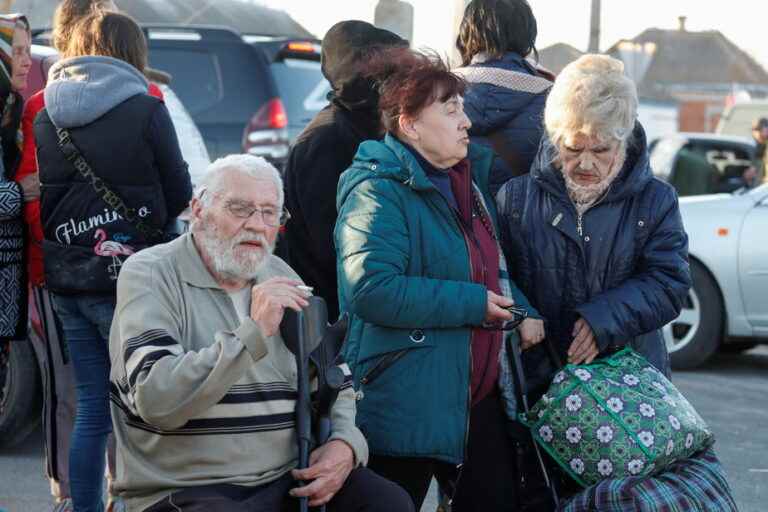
[663,261,723,369]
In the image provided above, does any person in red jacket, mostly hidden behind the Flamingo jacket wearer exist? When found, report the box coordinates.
[15,0,170,512]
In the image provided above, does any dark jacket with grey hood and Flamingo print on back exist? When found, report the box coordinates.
[34,56,192,294]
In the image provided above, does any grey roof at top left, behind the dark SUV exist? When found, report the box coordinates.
[6,0,313,37]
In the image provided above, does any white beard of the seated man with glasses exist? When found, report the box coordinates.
[193,221,275,281]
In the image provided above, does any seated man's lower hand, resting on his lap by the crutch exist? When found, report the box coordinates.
[290,439,355,507]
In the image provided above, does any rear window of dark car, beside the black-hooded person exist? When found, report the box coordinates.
[272,59,331,126]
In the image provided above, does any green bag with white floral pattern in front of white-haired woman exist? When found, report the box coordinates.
[521,349,714,487]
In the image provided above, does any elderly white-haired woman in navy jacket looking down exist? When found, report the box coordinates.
[497,55,691,386]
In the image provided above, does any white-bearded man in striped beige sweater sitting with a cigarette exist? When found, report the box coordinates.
[110,155,413,512]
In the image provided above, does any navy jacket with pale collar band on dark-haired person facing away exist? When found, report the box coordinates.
[464,53,549,194]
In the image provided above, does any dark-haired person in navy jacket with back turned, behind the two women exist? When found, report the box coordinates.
[454,0,554,194]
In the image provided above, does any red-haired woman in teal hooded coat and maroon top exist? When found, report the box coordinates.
[335,49,544,511]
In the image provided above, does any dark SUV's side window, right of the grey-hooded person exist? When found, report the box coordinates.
[150,48,224,116]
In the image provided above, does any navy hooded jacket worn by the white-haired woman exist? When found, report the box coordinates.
[497,124,691,385]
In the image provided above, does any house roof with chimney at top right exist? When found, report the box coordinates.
[606,28,768,100]
